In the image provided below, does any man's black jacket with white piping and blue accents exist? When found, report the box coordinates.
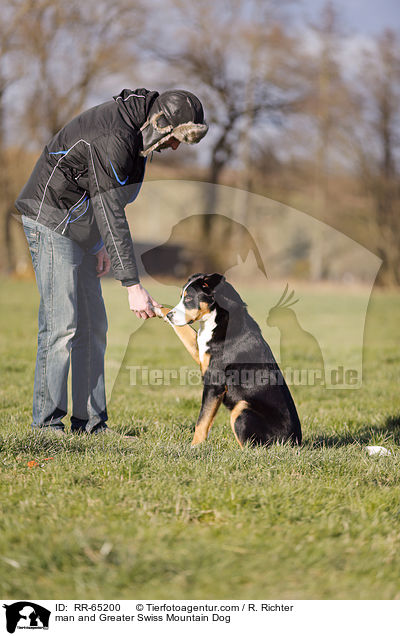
[15,88,158,285]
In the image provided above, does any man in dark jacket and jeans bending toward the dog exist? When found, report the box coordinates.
[16,88,208,434]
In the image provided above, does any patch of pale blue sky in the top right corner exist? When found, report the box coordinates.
[295,0,400,35]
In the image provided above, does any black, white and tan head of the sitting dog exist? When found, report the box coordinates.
[167,273,245,327]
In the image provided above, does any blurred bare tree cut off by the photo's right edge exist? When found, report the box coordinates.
[354,30,400,285]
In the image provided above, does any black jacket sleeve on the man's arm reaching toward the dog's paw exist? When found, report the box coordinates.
[88,135,139,285]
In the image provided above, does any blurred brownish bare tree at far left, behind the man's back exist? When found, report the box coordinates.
[0,0,144,270]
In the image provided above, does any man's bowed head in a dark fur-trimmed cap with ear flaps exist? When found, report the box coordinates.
[140,90,208,157]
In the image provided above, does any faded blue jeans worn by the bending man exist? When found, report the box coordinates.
[22,216,107,433]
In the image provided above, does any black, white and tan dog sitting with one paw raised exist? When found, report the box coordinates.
[155,273,302,448]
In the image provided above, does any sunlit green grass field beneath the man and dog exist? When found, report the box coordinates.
[0,281,400,599]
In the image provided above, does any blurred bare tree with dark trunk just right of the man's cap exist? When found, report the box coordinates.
[147,0,306,237]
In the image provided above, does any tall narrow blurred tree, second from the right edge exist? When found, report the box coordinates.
[282,2,354,280]
